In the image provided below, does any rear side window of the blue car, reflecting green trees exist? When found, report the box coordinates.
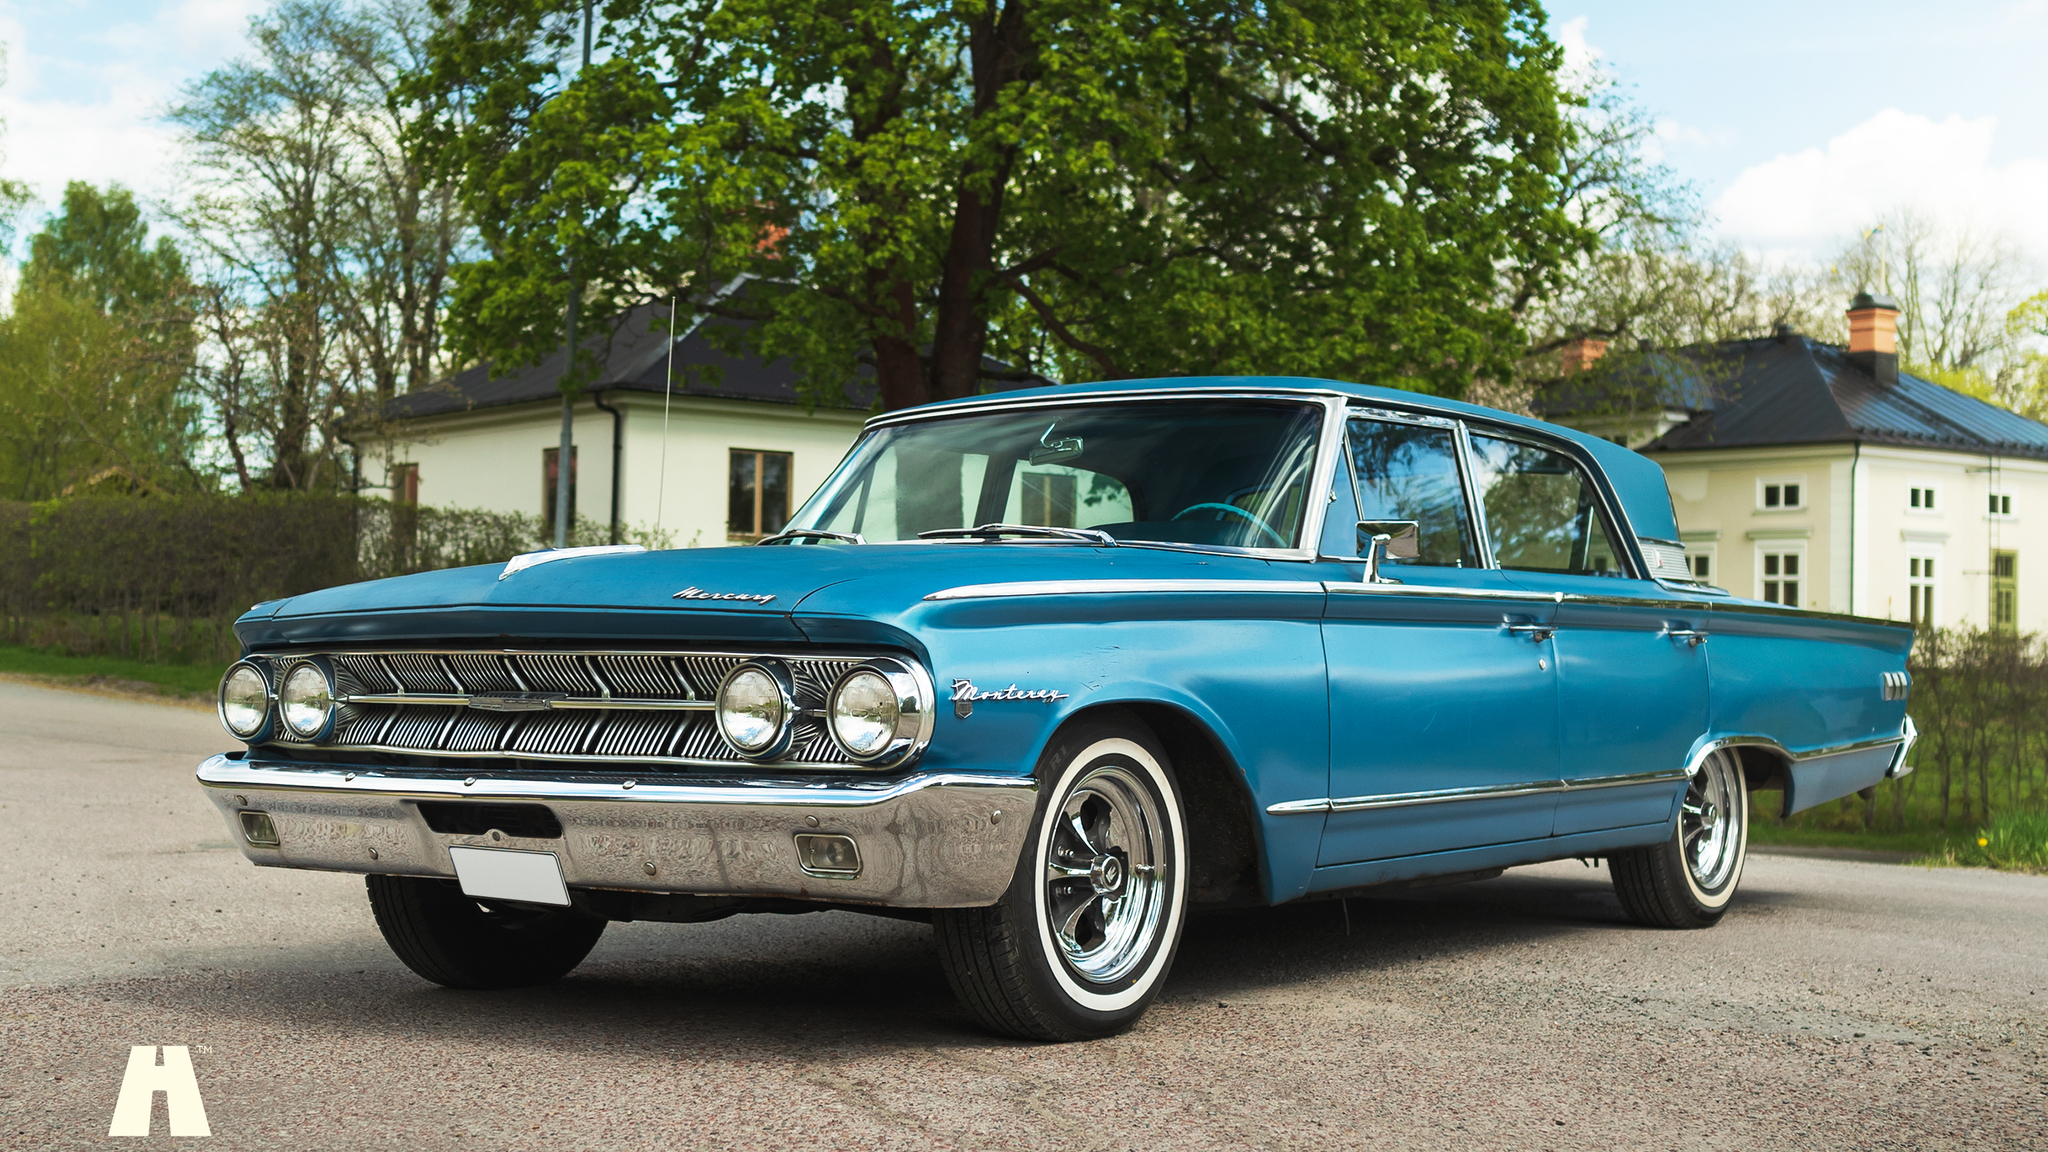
[1473,435,1624,576]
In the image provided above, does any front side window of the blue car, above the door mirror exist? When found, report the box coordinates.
[1350,418,1479,568]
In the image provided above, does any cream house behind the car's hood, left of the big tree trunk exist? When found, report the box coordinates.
[365,307,874,547]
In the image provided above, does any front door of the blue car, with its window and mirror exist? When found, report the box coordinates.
[1319,412,1559,865]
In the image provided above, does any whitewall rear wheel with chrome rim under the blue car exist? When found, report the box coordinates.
[1608,750,1749,929]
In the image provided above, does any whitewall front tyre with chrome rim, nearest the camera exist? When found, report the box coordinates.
[932,717,1188,1041]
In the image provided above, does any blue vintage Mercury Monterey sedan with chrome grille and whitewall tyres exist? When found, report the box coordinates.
[199,377,1913,1039]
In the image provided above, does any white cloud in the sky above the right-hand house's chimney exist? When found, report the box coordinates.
[1714,109,2048,264]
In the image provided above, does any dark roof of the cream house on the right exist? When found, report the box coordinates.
[1544,334,2048,459]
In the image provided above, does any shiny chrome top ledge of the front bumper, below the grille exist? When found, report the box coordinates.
[199,756,1038,808]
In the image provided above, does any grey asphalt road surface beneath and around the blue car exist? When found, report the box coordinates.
[0,683,2048,1152]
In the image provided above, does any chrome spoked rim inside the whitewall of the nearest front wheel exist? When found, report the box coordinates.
[1042,765,1167,984]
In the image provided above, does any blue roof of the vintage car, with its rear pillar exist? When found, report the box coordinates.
[877,375,1677,541]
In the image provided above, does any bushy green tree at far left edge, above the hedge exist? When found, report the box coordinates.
[0,182,199,500]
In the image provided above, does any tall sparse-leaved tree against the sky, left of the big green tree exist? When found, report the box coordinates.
[170,0,467,490]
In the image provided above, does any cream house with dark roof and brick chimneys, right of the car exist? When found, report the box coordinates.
[1544,293,2048,631]
